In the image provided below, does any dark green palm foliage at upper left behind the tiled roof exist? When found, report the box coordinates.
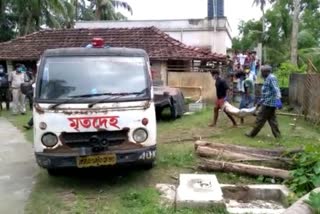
[0,0,132,38]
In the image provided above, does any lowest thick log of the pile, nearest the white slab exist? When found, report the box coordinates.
[198,159,291,179]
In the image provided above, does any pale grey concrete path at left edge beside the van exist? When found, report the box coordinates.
[0,118,38,214]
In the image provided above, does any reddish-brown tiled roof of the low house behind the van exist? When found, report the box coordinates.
[0,27,226,85]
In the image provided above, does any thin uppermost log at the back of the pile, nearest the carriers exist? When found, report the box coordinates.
[195,141,303,157]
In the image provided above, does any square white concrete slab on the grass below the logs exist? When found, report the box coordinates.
[176,174,224,207]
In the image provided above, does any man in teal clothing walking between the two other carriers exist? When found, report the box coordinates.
[239,69,255,124]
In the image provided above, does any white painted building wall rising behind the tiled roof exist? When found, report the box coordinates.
[75,18,231,54]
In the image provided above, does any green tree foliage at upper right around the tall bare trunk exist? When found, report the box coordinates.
[233,0,320,70]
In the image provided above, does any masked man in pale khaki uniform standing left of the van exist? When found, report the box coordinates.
[9,64,27,115]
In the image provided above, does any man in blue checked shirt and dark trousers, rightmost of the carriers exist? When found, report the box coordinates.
[246,66,282,138]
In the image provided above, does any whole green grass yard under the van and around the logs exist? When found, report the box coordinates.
[2,108,320,214]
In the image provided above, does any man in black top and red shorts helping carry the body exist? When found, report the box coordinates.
[209,71,237,127]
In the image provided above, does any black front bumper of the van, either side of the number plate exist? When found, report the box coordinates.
[35,146,156,169]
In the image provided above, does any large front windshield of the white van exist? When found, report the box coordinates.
[38,56,148,102]
